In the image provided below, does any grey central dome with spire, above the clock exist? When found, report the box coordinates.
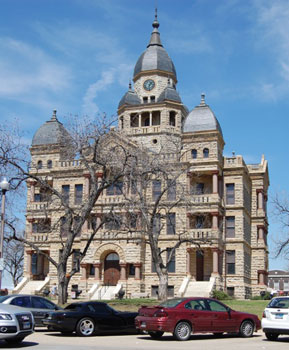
[134,14,177,81]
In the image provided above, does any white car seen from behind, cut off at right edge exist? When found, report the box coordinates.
[262,296,289,340]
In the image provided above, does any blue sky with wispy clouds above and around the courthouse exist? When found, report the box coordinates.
[0,0,289,280]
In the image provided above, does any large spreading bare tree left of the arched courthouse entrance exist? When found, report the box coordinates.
[0,116,129,304]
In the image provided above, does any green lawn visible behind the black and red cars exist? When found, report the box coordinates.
[105,299,269,319]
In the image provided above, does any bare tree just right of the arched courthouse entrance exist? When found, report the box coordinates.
[113,140,210,300]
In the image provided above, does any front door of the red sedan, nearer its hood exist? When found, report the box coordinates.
[207,299,236,332]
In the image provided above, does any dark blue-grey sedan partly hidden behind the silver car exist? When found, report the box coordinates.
[0,294,62,327]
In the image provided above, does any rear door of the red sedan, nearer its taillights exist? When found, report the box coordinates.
[184,299,212,332]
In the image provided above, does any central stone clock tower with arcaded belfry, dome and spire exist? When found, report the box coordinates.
[118,11,188,152]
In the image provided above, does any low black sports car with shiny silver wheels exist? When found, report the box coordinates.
[42,301,138,337]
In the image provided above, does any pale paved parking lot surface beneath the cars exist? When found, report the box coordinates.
[0,331,289,350]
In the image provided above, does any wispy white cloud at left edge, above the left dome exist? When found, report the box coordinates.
[0,37,71,103]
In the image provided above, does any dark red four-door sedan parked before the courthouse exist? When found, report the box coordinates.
[135,298,261,340]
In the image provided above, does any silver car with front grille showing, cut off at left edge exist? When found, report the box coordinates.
[0,304,34,344]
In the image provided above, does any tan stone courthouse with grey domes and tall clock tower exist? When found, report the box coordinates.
[15,12,269,299]
